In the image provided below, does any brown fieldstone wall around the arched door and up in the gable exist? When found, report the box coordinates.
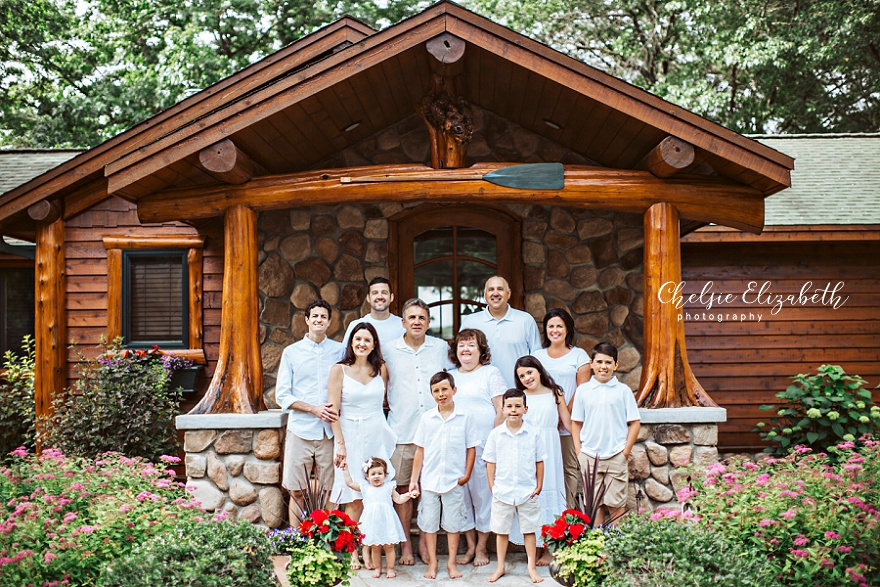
[258,108,644,406]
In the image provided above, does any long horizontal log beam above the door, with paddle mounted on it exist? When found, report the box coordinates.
[138,164,764,233]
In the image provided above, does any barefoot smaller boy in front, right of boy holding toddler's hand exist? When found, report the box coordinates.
[483,389,547,583]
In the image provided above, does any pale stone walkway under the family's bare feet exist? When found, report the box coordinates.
[351,552,559,587]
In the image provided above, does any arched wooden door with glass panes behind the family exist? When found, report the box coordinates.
[390,205,522,339]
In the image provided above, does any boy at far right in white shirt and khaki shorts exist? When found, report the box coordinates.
[571,342,641,524]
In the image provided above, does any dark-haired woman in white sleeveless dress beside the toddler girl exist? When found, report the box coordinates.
[327,322,397,566]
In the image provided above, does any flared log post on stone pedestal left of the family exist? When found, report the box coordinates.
[190,204,266,414]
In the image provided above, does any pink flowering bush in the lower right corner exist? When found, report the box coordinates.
[688,438,880,587]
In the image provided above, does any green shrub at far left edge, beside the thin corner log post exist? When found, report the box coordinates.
[0,335,34,454]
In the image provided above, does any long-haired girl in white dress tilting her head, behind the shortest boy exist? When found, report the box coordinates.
[510,355,571,566]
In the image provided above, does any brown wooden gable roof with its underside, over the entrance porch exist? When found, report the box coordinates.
[0,2,793,233]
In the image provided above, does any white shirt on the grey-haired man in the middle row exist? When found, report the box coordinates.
[382,336,452,444]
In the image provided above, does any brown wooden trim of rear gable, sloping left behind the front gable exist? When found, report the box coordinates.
[0,16,375,219]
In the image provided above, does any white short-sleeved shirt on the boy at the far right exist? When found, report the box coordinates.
[571,377,641,459]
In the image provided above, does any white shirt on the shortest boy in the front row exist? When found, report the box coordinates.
[483,421,547,505]
